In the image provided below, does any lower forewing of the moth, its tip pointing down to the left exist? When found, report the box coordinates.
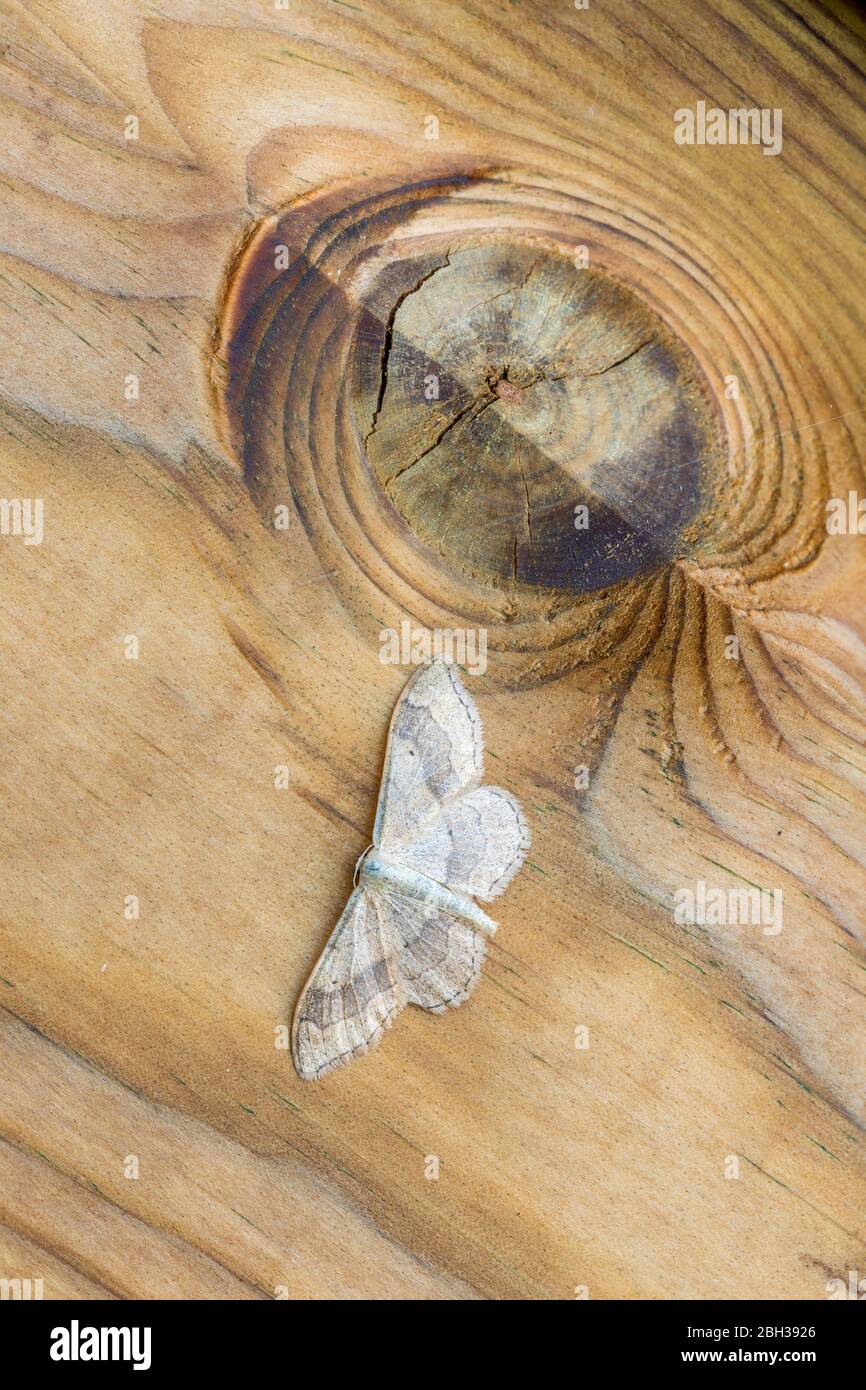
[292,887,407,1081]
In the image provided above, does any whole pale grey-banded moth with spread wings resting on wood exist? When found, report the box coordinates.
[292,660,530,1081]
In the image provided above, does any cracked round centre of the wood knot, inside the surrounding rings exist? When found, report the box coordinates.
[356,240,719,592]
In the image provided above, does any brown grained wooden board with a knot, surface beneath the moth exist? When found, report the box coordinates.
[0,0,866,1300]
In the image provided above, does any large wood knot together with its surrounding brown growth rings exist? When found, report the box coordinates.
[211,174,778,683]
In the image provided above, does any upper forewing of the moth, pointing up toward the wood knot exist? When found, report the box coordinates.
[373,662,484,849]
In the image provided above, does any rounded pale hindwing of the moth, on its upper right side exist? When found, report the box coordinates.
[399,787,530,902]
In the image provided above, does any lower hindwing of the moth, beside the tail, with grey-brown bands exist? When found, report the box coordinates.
[384,894,485,1013]
